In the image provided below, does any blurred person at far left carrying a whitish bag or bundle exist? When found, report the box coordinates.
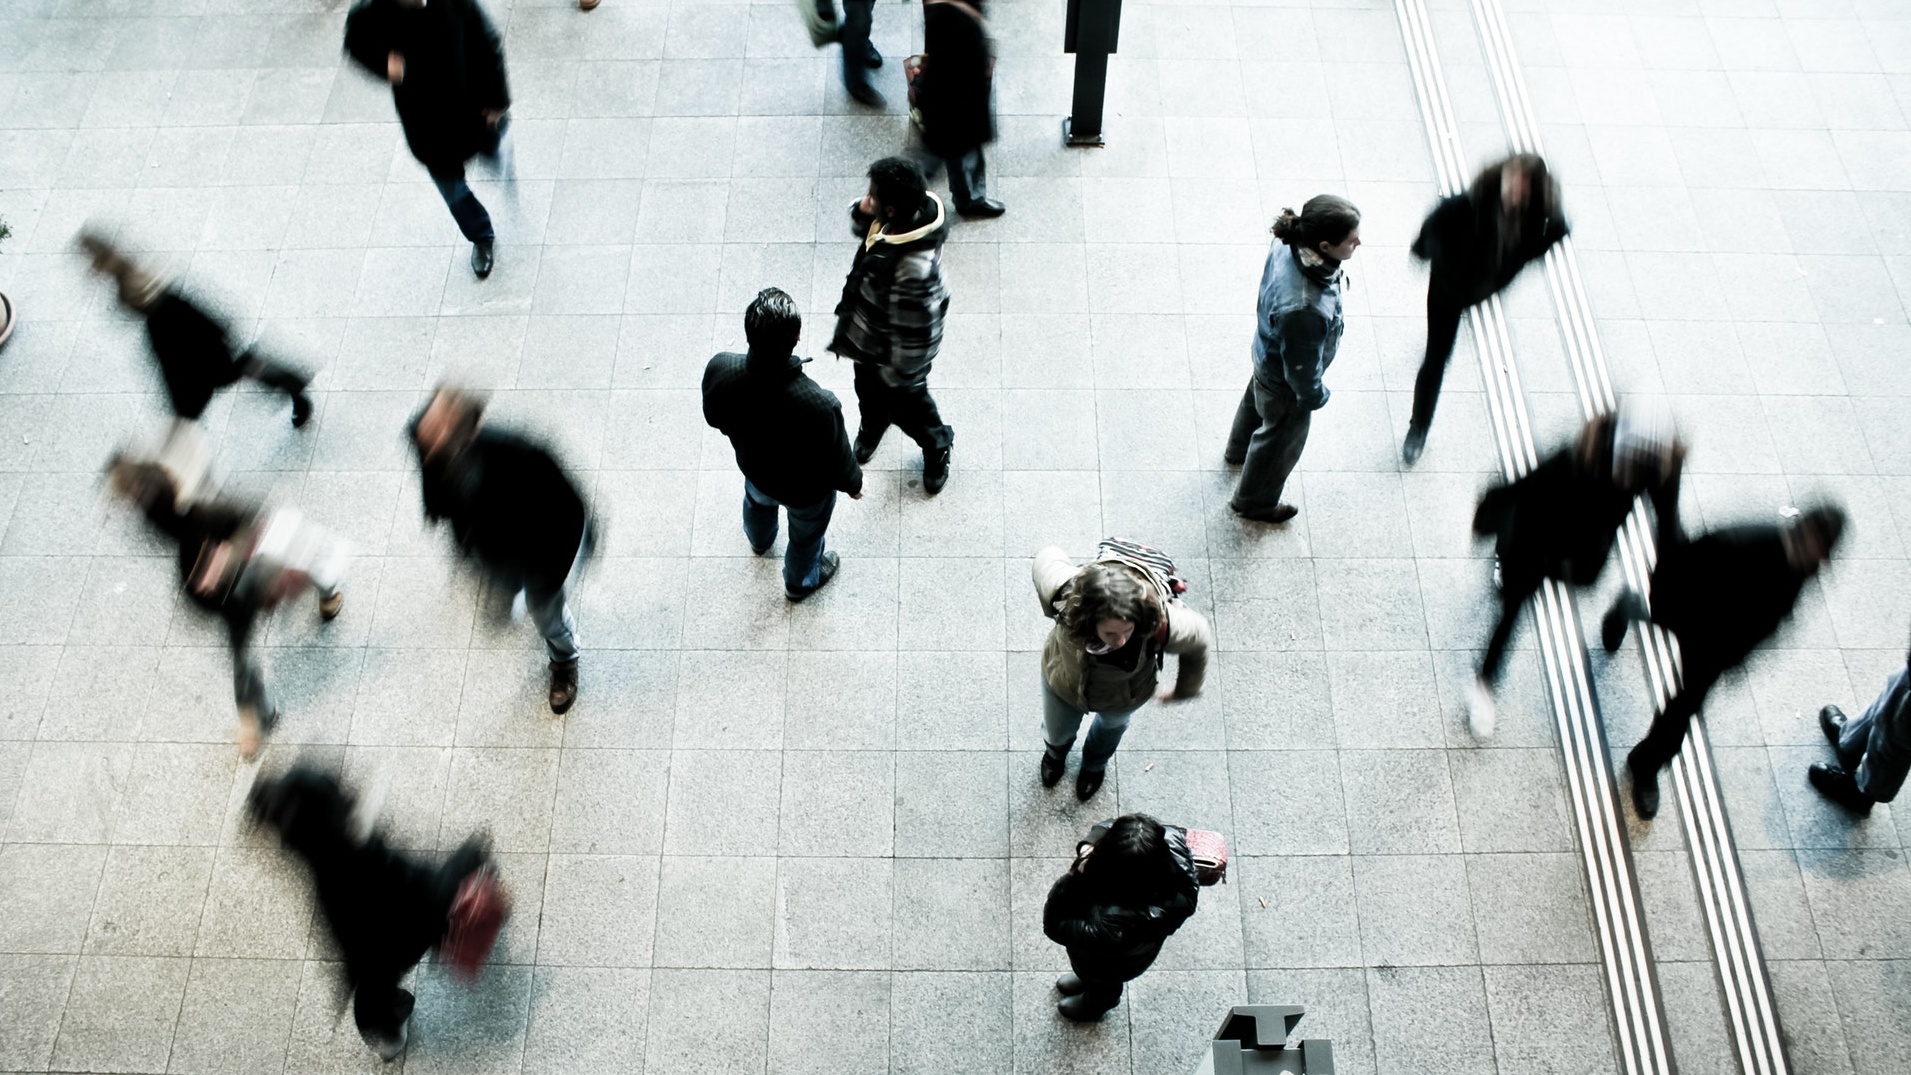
[107,437,350,758]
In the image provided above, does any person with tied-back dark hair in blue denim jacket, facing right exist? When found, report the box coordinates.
[1225,195,1361,523]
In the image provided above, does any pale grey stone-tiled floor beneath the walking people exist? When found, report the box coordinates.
[0,0,1911,1075]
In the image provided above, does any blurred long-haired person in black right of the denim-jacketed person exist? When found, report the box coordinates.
[1401,153,1569,466]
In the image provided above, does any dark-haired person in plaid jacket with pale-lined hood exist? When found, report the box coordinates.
[829,157,956,496]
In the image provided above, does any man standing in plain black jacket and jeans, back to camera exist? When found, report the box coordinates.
[703,288,862,601]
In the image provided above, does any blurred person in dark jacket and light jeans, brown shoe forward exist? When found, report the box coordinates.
[411,386,590,714]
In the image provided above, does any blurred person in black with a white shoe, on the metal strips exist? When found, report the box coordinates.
[1468,407,1686,737]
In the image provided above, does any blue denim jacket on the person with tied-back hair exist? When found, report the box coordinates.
[1254,241,1345,411]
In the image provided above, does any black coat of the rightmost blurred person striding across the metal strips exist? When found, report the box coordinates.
[1651,525,1808,668]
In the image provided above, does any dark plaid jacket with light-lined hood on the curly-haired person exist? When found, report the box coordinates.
[829,195,950,388]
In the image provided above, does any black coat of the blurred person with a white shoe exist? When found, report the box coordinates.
[1473,447,1680,590]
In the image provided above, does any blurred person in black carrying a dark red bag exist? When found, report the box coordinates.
[247,766,510,1062]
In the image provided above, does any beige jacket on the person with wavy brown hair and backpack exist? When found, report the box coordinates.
[1032,546,1213,712]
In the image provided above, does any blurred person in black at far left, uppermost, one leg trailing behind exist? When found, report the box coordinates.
[78,229,311,428]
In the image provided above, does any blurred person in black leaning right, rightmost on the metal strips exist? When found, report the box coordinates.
[1601,506,1844,817]
